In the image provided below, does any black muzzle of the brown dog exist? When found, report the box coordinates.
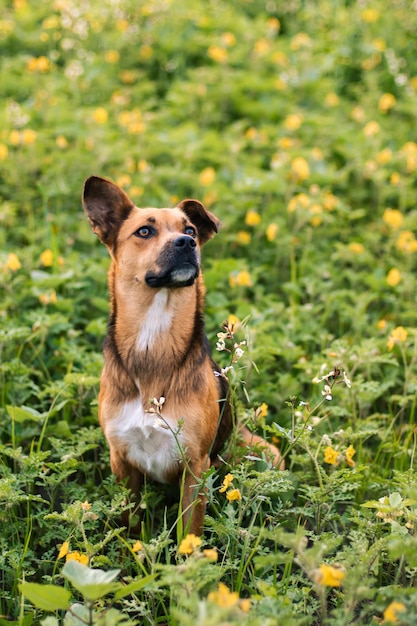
[145,235,200,288]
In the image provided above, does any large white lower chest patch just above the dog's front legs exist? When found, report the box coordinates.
[105,398,181,483]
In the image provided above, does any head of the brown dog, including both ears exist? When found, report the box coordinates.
[79,176,220,288]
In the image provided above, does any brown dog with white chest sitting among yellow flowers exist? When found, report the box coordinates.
[83,176,281,534]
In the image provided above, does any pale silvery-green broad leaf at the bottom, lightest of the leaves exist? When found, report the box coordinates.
[62,561,120,601]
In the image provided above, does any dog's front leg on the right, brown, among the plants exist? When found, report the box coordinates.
[181,455,210,535]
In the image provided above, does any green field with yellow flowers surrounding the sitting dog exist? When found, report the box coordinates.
[0,0,417,626]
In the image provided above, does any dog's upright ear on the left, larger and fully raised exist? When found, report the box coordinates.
[82,176,134,248]
